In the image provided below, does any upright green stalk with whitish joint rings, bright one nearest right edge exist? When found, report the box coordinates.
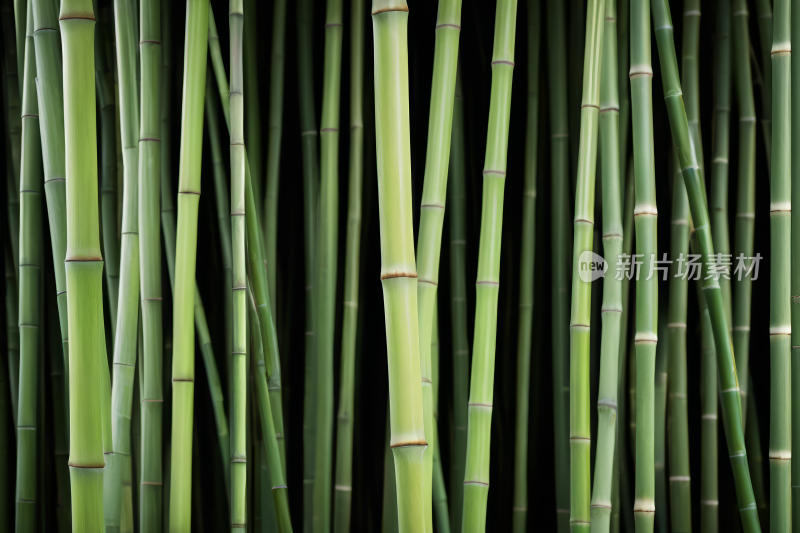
[764,0,800,531]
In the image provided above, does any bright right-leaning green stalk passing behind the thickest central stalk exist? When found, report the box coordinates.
[417,0,461,533]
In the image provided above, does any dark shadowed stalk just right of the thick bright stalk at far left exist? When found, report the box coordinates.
[94,7,120,335]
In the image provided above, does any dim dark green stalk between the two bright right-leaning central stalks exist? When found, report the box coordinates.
[447,68,469,531]
